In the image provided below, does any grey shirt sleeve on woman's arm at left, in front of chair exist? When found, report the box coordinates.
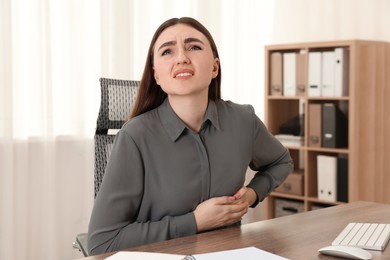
[88,131,196,255]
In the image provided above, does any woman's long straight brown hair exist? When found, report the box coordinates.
[130,17,221,118]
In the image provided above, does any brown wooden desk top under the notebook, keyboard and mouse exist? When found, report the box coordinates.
[82,202,390,260]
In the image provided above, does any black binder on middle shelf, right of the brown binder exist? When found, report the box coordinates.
[321,103,348,148]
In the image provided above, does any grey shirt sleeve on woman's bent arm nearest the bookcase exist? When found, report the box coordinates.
[248,108,294,204]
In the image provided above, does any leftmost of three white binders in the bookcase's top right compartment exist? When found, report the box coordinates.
[308,52,322,97]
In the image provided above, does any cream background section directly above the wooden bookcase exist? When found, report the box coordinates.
[272,0,390,43]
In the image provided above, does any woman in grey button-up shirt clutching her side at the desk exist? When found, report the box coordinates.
[88,17,293,254]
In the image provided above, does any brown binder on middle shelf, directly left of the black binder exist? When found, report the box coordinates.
[308,104,322,147]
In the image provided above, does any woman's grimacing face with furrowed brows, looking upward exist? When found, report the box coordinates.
[153,24,219,97]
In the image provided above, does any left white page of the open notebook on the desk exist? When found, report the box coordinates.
[105,251,184,260]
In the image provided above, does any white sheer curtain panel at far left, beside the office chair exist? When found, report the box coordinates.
[0,0,101,259]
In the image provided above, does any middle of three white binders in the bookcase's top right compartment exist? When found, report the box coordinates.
[321,51,335,97]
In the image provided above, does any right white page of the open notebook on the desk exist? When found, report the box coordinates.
[190,247,287,260]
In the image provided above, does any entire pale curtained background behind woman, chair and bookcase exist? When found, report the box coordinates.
[0,0,390,259]
